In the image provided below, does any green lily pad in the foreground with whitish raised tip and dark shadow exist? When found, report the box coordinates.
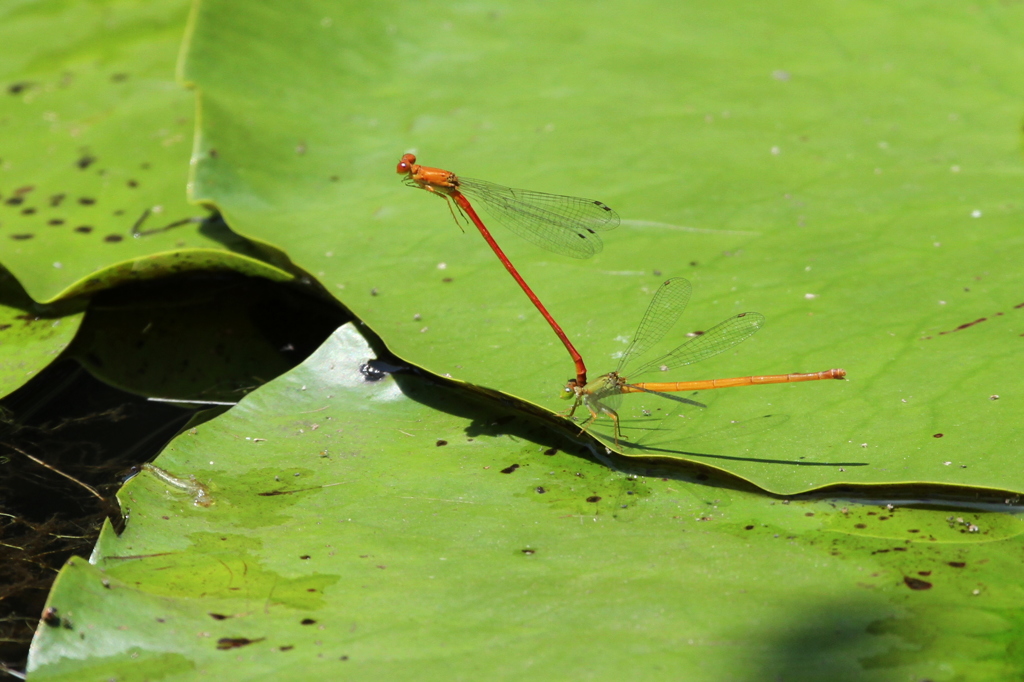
[30,326,1024,681]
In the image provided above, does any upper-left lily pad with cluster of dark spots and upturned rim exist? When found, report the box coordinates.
[0,0,291,301]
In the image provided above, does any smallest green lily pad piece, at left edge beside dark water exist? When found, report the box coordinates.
[0,267,83,397]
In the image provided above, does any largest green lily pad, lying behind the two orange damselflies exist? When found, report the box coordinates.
[183,0,1024,492]
